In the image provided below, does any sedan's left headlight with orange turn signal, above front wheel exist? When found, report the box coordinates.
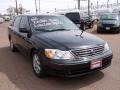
[45,49,73,59]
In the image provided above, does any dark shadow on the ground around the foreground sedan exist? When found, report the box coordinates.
[0,47,104,90]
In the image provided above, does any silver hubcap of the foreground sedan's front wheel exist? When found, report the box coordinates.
[33,54,41,74]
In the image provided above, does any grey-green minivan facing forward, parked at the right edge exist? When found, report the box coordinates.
[97,13,120,33]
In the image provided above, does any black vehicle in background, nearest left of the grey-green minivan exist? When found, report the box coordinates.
[81,16,94,28]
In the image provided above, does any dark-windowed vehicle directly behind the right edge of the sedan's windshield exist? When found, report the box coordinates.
[58,11,86,30]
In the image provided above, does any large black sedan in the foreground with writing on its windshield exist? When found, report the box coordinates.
[8,15,113,77]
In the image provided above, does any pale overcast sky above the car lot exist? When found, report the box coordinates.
[0,0,117,13]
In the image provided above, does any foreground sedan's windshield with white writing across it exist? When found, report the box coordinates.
[29,16,79,31]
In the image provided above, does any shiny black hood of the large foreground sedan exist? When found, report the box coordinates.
[36,30,104,50]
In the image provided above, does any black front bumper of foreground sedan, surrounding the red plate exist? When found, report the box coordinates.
[44,52,113,77]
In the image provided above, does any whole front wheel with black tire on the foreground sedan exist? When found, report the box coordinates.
[32,52,46,78]
